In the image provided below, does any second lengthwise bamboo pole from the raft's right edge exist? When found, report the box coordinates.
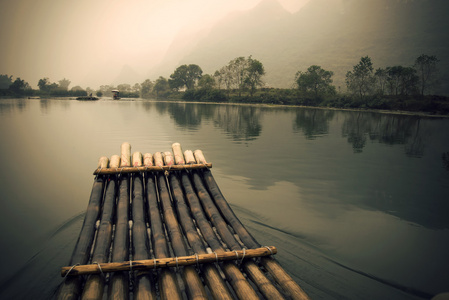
[189,171,284,299]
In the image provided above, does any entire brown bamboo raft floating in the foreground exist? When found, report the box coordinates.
[57,143,309,300]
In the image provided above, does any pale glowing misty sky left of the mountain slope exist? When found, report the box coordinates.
[0,0,308,88]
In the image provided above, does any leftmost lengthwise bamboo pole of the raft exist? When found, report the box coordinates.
[57,158,107,300]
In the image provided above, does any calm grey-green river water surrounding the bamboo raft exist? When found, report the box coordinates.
[0,99,449,299]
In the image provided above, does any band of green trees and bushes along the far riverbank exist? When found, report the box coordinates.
[0,54,449,116]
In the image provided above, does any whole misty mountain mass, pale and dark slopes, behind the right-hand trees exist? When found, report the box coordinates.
[150,0,449,95]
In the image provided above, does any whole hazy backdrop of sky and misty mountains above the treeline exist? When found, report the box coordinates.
[0,0,449,95]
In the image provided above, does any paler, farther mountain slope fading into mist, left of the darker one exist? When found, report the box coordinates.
[151,0,291,77]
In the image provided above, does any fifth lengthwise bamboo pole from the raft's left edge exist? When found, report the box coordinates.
[145,152,181,300]
